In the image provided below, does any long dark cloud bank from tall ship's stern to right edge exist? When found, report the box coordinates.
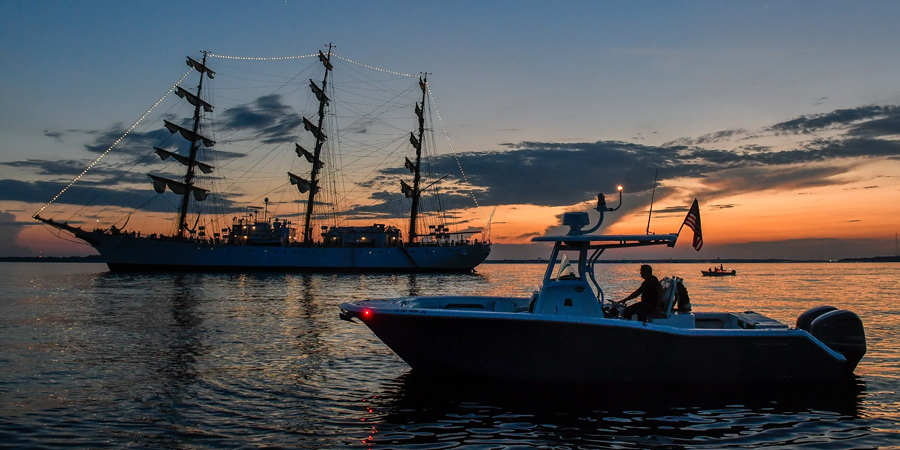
[426,134,900,206]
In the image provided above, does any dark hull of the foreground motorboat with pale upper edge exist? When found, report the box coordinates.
[341,299,856,384]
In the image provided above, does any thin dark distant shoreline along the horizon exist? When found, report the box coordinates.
[0,255,900,264]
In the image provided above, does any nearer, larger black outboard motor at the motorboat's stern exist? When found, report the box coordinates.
[809,309,866,375]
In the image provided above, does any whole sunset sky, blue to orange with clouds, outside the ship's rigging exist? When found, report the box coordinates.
[0,0,900,259]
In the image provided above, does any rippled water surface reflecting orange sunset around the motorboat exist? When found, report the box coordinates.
[0,263,900,449]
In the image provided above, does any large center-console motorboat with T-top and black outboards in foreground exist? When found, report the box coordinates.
[340,191,866,384]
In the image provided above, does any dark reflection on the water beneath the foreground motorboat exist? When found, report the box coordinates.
[370,372,865,448]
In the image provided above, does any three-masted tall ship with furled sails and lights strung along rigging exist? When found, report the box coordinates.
[33,45,491,273]
